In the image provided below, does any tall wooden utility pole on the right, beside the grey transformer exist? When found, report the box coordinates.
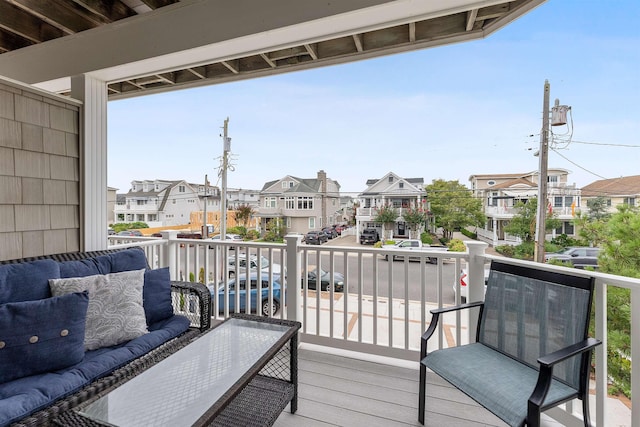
[534,80,551,262]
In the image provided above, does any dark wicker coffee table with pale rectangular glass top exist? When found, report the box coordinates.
[56,315,300,427]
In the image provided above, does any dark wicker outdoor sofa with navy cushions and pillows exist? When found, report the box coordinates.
[0,248,211,426]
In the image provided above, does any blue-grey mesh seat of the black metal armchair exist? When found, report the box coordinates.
[421,343,578,426]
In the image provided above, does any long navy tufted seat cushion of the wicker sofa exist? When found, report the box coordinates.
[0,315,189,426]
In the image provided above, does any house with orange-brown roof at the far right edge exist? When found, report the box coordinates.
[580,175,640,213]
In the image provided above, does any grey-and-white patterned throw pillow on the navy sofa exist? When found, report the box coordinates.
[49,270,148,350]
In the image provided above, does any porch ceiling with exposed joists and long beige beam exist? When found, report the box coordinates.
[0,0,545,99]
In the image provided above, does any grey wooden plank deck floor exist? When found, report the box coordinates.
[275,348,559,427]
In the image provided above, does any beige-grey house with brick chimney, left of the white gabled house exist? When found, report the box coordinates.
[258,170,341,234]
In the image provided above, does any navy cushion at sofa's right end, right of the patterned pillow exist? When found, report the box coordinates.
[142,267,173,325]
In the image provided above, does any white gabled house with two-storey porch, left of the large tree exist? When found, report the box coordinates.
[356,172,427,238]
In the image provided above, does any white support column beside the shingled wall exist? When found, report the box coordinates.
[71,75,107,251]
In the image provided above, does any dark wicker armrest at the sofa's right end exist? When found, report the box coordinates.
[171,281,211,331]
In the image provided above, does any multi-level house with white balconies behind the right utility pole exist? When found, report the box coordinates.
[469,168,580,246]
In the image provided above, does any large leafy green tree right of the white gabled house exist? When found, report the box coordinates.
[425,179,485,239]
